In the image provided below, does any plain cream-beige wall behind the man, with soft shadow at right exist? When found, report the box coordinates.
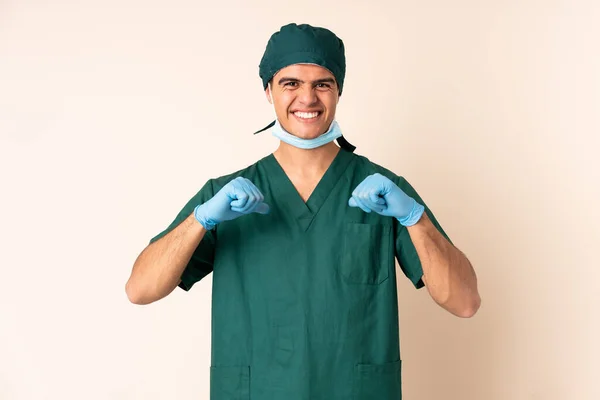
[0,0,600,400]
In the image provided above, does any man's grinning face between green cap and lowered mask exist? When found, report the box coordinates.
[265,64,339,139]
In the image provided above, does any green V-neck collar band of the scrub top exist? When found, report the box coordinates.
[266,148,352,231]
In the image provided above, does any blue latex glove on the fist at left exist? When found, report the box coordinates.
[194,177,269,231]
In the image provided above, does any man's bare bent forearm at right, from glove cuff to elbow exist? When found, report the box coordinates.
[408,213,481,317]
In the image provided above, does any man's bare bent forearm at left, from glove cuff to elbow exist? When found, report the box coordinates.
[125,214,206,304]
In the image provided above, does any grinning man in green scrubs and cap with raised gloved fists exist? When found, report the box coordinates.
[126,24,480,400]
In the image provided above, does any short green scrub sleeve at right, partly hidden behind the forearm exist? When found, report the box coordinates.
[394,177,452,289]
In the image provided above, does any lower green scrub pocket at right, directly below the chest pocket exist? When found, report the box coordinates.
[353,360,402,400]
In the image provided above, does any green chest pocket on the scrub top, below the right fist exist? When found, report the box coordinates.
[339,222,393,285]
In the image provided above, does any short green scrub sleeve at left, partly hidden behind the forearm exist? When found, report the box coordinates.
[150,180,216,291]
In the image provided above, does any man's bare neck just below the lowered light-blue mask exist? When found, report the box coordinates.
[273,141,341,176]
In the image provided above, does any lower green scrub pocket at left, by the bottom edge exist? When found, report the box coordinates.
[210,366,250,400]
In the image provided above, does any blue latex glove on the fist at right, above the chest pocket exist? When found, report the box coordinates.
[348,174,425,226]
